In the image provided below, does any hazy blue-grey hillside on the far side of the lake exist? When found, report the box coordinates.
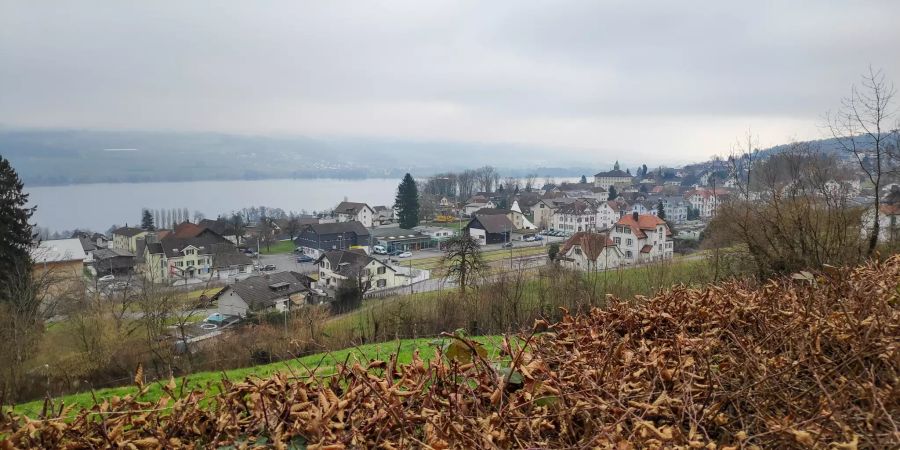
[0,128,583,185]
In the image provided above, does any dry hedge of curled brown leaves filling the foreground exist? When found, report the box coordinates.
[0,257,900,449]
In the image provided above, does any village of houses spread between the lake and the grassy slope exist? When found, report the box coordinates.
[33,152,900,339]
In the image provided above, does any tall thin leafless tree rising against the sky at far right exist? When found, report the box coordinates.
[828,66,898,256]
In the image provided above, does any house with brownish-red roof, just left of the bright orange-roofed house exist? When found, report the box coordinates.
[557,231,625,271]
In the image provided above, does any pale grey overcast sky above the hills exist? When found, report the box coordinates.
[0,0,900,162]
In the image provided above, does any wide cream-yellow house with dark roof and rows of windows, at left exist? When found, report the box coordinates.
[144,229,253,282]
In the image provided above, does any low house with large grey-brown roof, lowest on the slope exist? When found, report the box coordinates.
[213,272,311,317]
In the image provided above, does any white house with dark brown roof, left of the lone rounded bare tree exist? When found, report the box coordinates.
[315,250,407,296]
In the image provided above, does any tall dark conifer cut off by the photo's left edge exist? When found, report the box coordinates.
[0,156,36,301]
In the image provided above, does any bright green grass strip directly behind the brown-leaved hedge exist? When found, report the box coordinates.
[13,336,502,417]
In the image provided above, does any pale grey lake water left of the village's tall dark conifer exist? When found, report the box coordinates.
[25,178,400,232]
